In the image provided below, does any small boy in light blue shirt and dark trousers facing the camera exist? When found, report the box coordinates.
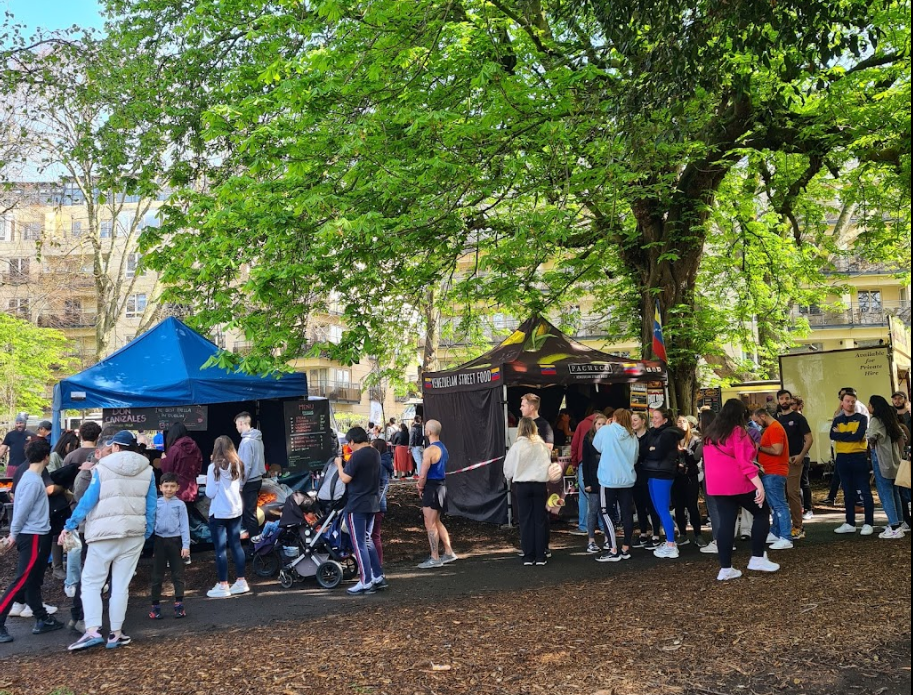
[149,473,190,620]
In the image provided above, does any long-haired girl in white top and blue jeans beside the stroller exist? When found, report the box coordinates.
[206,434,250,598]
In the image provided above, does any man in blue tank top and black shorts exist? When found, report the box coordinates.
[415,420,457,569]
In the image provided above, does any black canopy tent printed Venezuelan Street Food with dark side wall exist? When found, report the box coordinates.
[422,317,666,523]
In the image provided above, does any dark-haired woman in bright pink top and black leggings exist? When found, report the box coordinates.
[704,398,780,581]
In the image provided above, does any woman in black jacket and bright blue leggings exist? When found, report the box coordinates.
[640,408,685,559]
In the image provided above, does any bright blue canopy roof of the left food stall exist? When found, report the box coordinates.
[52,318,307,441]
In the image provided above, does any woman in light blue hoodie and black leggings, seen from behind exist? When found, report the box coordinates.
[593,408,639,562]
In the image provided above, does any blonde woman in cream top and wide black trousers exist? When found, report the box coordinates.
[504,417,551,566]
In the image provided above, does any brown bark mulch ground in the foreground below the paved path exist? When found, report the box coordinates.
[0,484,911,695]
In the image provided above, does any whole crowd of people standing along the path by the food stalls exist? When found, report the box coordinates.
[0,388,910,651]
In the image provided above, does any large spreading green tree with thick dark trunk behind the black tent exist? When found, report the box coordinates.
[96,0,910,409]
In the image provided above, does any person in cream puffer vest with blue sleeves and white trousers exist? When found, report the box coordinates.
[60,431,156,651]
